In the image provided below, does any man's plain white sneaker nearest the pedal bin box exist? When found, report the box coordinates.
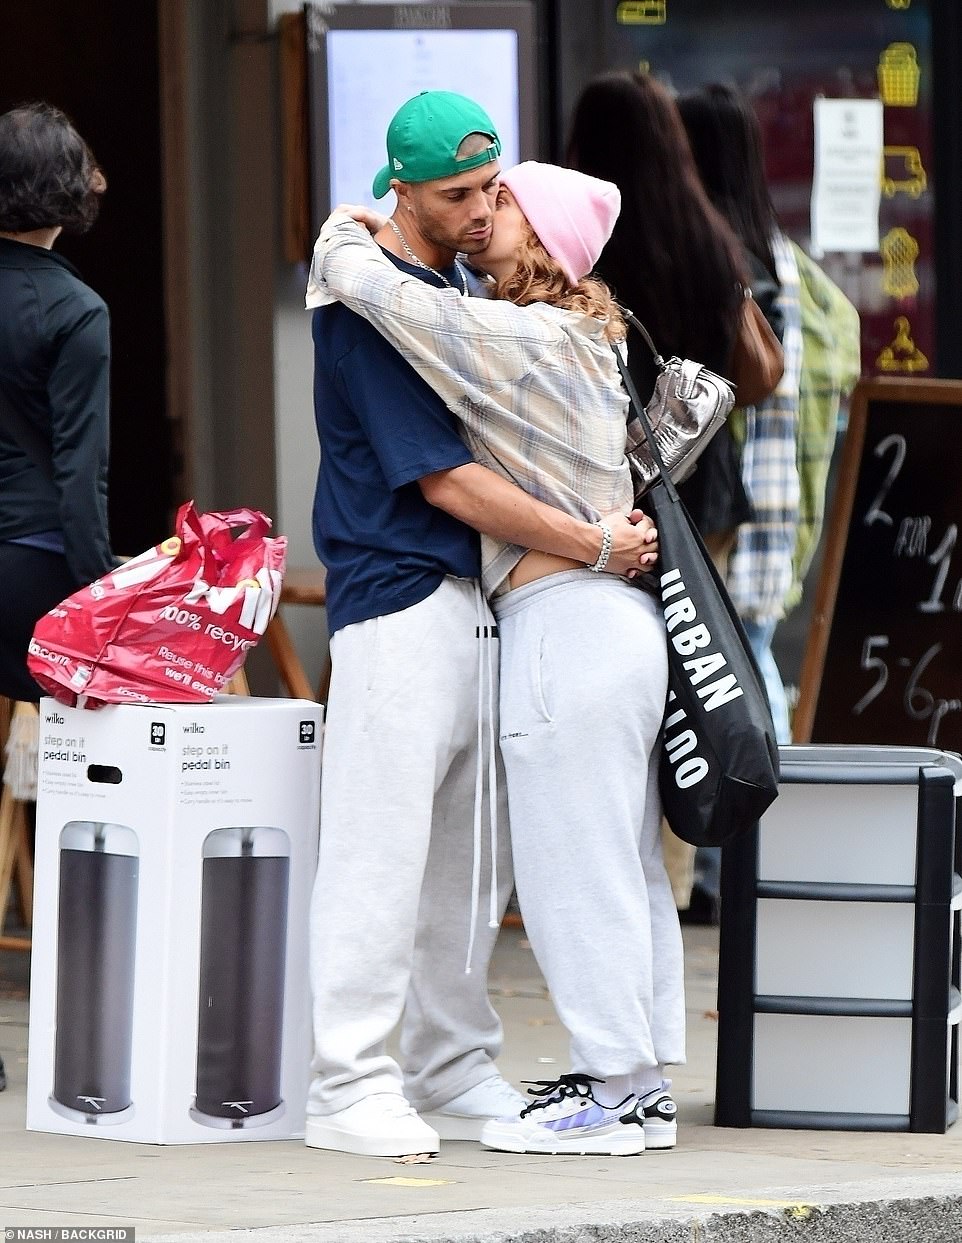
[305,1091,441,1157]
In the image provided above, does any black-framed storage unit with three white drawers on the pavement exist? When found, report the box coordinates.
[715,746,962,1134]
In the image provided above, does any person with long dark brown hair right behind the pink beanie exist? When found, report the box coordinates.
[567,71,752,559]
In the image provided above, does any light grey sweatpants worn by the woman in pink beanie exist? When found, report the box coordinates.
[493,569,685,1078]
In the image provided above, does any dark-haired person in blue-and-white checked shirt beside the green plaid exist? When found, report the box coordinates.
[679,83,802,922]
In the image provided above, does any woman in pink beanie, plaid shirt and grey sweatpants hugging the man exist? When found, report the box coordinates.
[308,163,685,1154]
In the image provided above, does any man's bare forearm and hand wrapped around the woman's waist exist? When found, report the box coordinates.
[418,462,657,574]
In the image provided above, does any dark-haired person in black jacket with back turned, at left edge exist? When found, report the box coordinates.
[0,103,114,701]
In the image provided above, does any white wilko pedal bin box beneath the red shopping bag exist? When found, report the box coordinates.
[26,696,323,1144]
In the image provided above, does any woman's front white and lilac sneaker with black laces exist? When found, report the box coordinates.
[481,1074,645,1156]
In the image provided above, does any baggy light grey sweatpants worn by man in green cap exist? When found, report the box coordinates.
[313,578,512,1114]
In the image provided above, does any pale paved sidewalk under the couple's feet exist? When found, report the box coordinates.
[0,929,962,1243]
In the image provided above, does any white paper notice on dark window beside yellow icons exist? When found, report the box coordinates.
[812,99,884,255]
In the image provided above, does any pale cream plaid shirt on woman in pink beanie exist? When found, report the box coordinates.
[306,213,633,595]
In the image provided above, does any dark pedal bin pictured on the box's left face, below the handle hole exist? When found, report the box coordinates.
[50,820,139,1125]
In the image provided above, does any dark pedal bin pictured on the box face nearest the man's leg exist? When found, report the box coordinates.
[190,827,291,1129]
